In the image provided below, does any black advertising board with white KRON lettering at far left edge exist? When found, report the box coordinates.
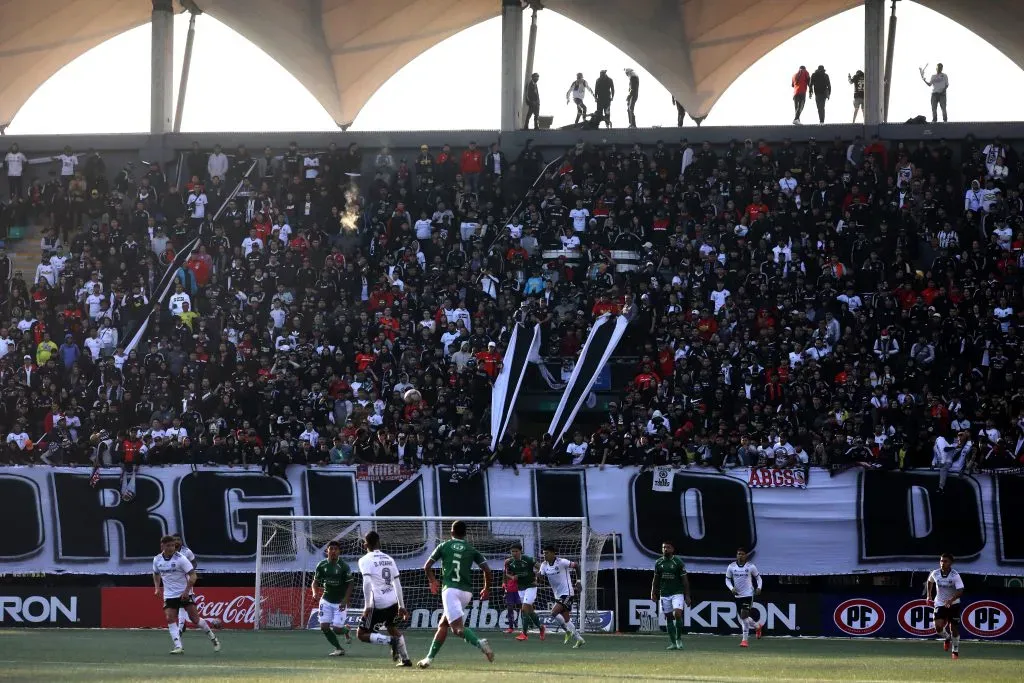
[0,586,99,629]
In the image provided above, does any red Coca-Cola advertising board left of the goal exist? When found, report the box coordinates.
[101,586,289,629]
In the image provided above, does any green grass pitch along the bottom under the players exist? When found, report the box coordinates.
[0,629,1024,683]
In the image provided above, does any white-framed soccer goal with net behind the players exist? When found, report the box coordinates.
[254,516,608,631]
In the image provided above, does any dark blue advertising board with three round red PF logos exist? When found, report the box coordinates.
[821,587,1024,640]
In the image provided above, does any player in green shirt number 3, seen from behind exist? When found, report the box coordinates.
[416,521,495,669]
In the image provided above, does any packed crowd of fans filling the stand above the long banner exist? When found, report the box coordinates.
[0,132,1024,471]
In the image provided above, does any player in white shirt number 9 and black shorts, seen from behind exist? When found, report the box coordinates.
[355,531,413,667]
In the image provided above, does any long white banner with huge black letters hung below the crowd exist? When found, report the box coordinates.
[0,466,1024,575]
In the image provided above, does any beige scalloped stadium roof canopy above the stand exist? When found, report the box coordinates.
[0,0,1024,124]
